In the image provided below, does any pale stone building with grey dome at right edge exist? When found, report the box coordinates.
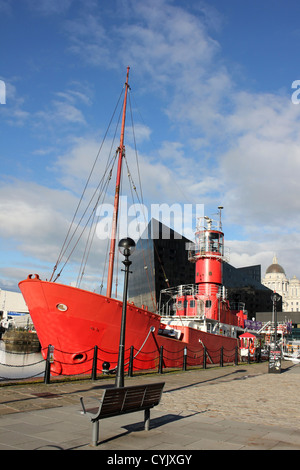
[261,256,300,312]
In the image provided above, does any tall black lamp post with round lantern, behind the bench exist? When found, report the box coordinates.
[115,238,135,387]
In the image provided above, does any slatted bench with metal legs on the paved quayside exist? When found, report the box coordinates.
[80,382,165,446]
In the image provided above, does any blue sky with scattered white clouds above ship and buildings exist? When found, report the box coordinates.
[0,0,300,289]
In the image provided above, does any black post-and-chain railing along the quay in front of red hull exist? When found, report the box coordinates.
[0,345,268,384]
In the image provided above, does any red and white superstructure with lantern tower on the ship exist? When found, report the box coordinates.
[159,211,247,344]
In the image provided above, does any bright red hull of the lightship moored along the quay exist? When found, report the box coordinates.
[19,276,237,375]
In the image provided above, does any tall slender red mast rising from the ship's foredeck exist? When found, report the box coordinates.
[106,67,130,297]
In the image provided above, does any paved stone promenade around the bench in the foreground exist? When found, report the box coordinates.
[0,361,300,452]
